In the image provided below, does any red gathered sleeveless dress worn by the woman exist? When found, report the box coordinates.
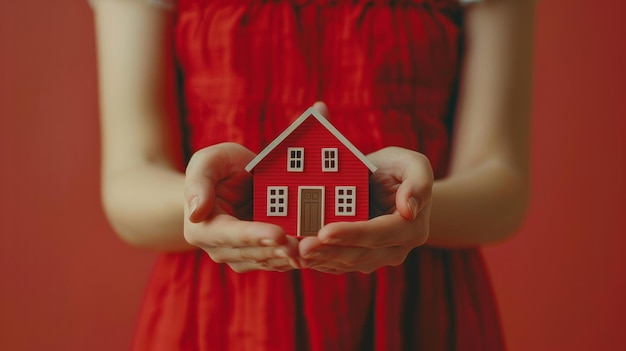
[133,0,504,351]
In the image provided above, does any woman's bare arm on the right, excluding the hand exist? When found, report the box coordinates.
[427,0,535,246]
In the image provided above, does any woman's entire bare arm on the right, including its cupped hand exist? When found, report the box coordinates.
[299,0,534,273]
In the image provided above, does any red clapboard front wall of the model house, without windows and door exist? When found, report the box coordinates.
[253,117,369,235]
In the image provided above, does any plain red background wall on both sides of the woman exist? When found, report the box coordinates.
[0,0,626,351]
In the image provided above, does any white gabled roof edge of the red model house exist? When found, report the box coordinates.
[246,106,377,173]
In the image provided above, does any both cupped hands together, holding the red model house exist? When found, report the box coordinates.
[184,102,433,274]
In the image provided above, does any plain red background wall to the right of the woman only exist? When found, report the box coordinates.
[485,0,626,350]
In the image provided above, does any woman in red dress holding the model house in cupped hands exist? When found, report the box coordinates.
[93,0,534,350]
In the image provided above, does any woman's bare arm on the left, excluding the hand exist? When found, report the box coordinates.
[93,1,191,250]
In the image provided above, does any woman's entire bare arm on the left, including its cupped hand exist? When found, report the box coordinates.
[94,1,299,266]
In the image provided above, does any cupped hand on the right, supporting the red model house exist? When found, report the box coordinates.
[299,147,433,274]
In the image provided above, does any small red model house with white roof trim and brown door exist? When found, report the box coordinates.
[246,107,376,236]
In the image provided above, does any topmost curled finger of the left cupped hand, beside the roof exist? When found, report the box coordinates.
[185,143,254,223]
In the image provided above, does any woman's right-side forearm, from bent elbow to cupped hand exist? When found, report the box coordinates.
[428,161,529,247]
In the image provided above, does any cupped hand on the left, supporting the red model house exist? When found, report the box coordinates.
[184,143,300,273]
